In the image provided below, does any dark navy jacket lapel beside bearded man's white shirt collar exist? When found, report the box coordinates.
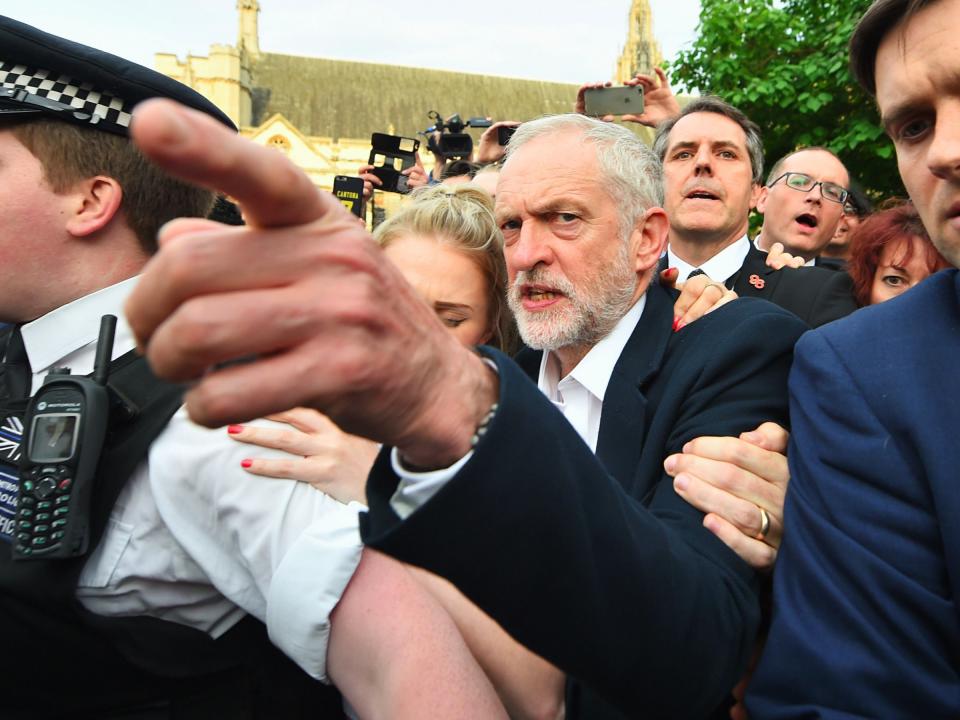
[597,283,673,488]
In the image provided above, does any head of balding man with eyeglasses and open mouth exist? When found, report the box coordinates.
[756,147,850,266]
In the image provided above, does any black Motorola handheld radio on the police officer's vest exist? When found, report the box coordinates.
[13,315,117,560]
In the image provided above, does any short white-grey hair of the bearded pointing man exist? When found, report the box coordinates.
[504,113,663,236]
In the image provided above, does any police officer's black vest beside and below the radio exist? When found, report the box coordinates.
[0,352,343,720]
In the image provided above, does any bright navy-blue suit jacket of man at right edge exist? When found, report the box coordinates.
[748,270,960,718]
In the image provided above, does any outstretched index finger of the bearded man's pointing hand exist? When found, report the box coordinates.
[130,99,336,227]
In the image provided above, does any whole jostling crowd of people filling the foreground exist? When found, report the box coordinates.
[0,0,960,720]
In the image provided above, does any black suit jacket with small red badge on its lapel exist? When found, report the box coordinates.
[727,243,857,327]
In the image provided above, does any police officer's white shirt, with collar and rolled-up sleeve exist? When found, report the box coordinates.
[22,278,362,678]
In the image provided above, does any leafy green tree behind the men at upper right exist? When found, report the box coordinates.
[670,0,905,199]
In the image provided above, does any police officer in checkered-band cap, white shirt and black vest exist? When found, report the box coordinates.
[0,17,360,718]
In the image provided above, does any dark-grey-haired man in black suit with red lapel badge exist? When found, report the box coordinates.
[653,96,857,327]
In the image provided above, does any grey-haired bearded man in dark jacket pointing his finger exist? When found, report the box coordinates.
[128,104,804,718]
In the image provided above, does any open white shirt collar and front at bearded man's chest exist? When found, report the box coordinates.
[537,295,647,452]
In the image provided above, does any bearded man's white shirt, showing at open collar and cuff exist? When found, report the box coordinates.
[390,295,647,519]
